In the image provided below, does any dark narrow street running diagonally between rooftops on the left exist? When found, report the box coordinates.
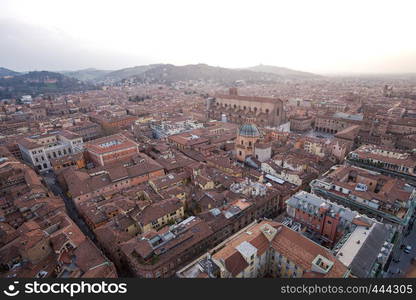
[42,173,95,241]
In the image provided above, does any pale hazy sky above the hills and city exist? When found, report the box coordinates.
[0,0,416,73]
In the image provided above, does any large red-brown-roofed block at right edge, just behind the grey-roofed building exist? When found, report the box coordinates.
[310,165,416,227]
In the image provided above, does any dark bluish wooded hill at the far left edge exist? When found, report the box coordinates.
[0,71,96,99]
